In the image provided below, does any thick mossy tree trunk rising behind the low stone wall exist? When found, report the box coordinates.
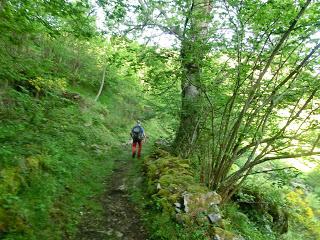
[173,0,211,157]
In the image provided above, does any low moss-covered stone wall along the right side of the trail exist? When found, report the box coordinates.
[144,148,246,240]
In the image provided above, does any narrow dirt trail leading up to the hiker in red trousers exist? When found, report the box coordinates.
[77,155,148,240]
